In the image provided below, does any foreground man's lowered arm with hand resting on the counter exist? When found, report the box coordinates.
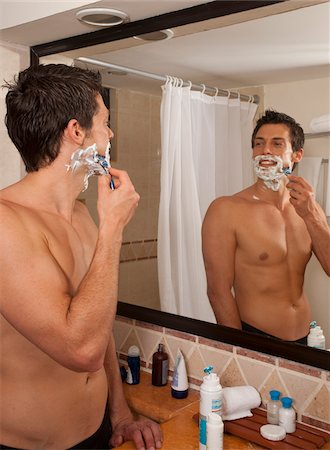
[104,335,163,450]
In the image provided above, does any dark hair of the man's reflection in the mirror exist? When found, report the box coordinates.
[252,109,305,152]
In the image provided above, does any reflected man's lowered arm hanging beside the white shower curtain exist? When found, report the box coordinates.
[202,197,241,329]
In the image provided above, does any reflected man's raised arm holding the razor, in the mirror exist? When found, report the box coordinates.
[287,175,330,276]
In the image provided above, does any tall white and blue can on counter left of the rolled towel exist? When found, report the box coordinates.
[199,366,222,450]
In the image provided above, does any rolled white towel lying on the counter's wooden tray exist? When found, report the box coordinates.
[222,386,261,420]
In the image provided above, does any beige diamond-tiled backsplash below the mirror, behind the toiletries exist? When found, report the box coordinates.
[114,316,330,431]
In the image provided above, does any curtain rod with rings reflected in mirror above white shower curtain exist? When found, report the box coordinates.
[76,56,259,104]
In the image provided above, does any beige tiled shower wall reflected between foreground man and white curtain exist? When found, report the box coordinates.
[80,89,161,309]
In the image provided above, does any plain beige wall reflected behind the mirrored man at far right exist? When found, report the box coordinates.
[264,78,330,347]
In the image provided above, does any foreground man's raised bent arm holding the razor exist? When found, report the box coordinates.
[0,169,139,372]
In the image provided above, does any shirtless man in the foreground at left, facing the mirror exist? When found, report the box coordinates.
[0,64,162,450]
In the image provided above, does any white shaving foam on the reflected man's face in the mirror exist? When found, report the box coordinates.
[253,155,291,191]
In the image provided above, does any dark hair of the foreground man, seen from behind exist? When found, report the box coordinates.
[3,64,102,172]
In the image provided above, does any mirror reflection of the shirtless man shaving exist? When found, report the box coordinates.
[202,111,330,343]
